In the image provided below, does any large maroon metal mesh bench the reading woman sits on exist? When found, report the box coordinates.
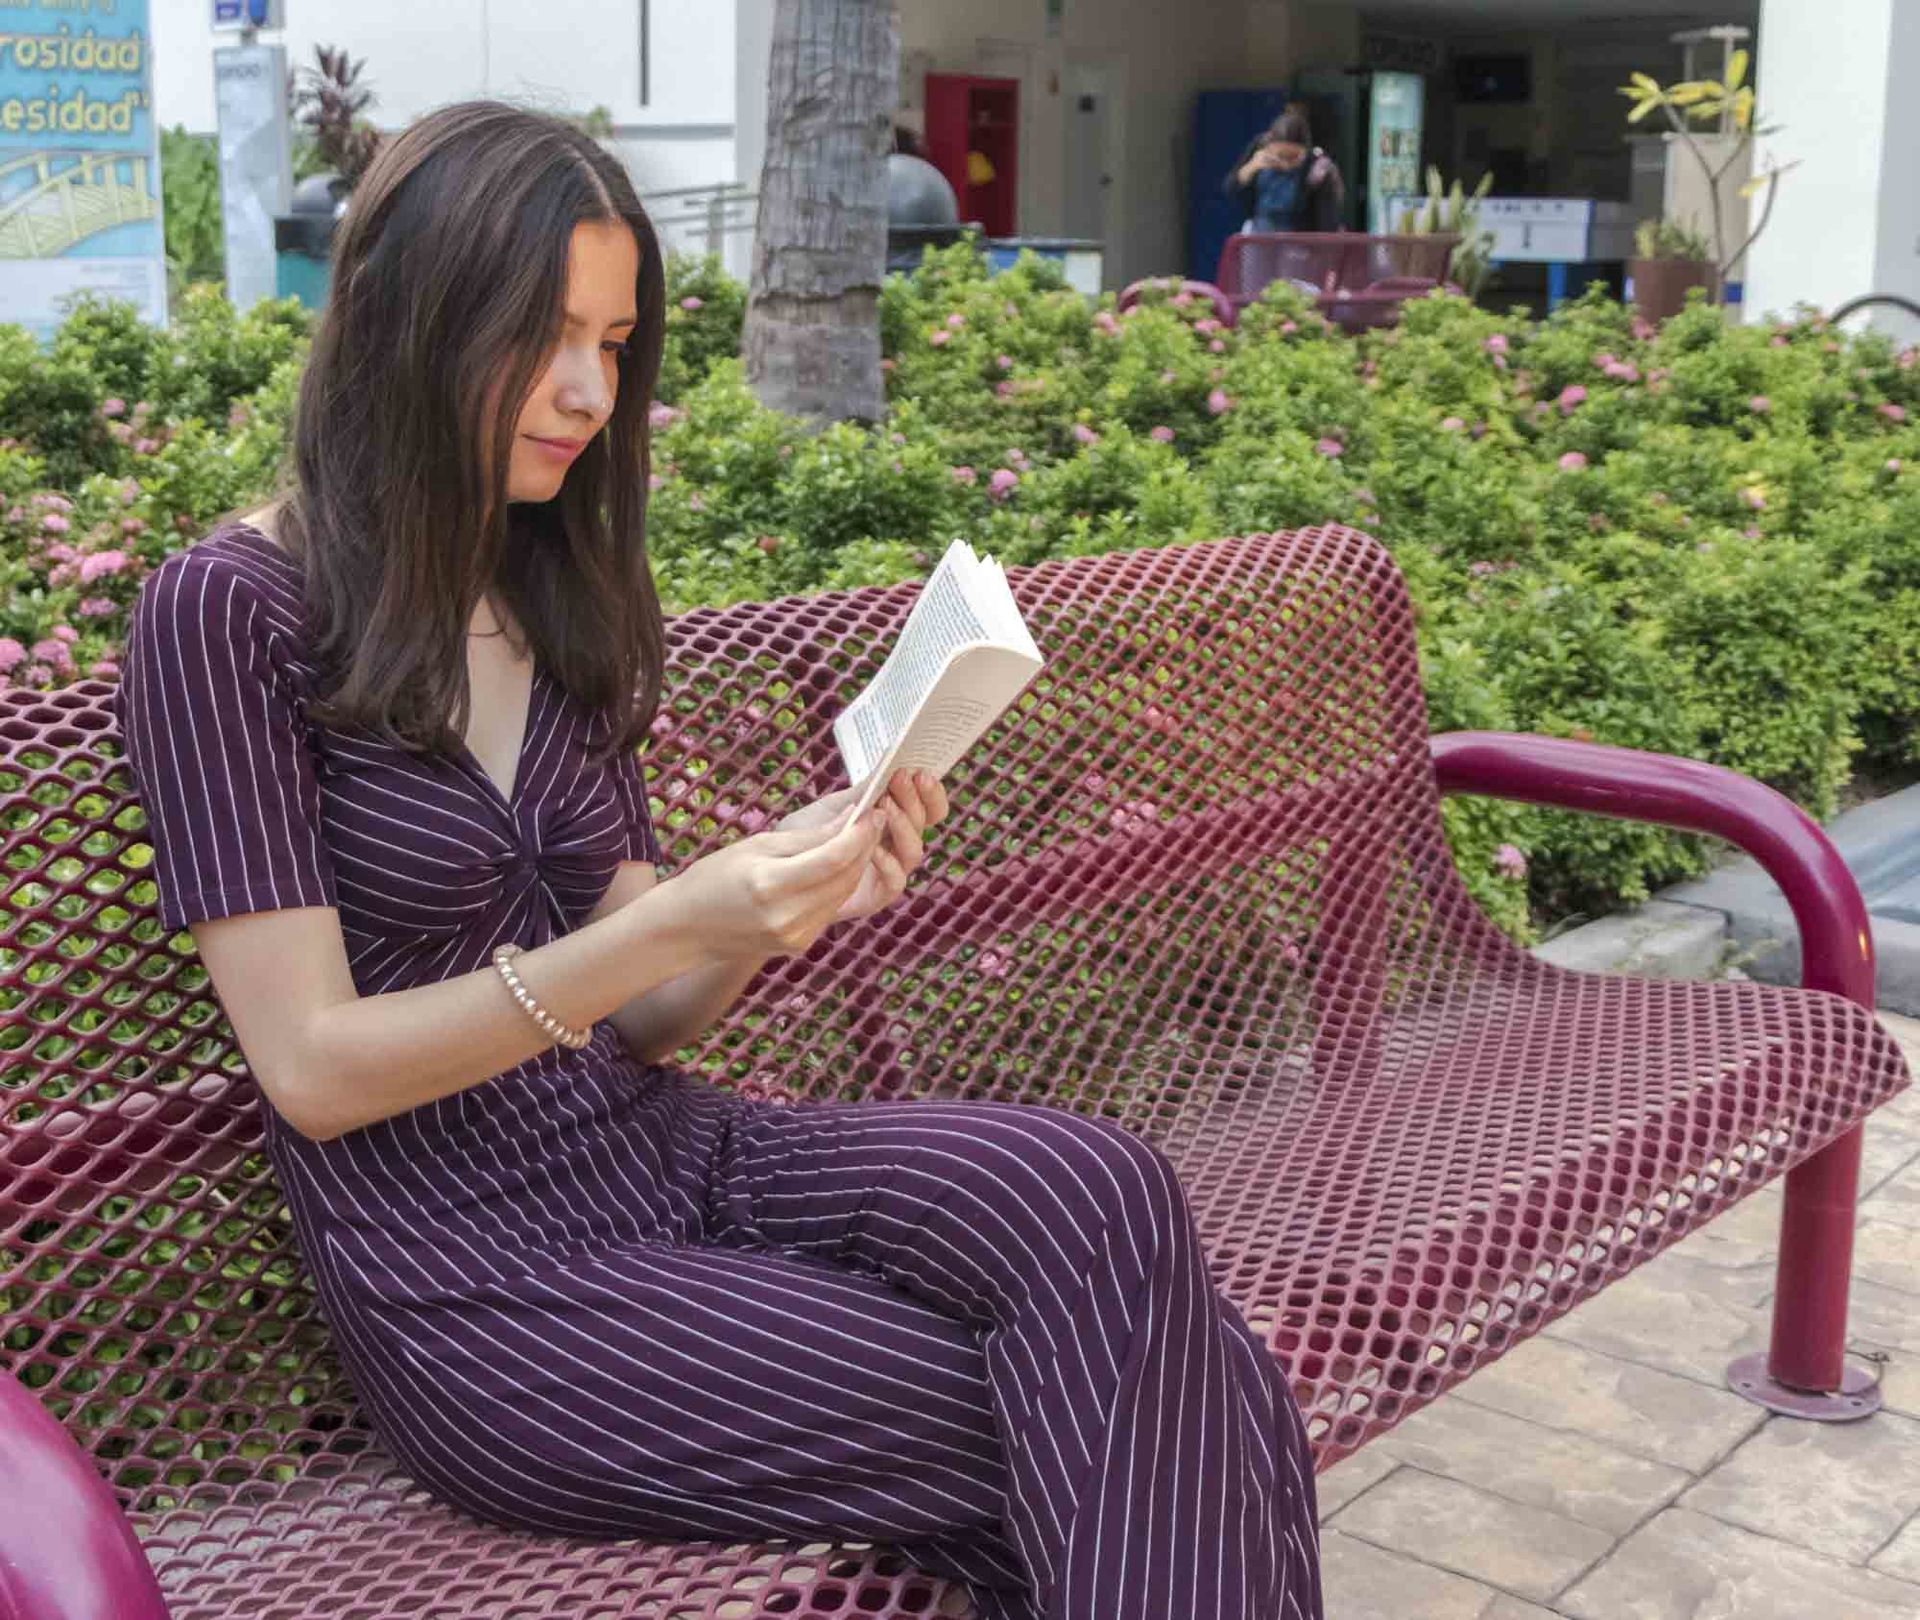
[0,530,1907,1620]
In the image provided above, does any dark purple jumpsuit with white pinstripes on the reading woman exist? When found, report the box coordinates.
[115,524,1321,1620]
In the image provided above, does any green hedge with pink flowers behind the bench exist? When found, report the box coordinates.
[0,248,1920,933]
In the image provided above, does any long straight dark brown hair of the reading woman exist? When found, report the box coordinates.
[276,102,666,752]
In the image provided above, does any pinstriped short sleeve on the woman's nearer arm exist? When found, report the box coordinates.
[115,551,336,929]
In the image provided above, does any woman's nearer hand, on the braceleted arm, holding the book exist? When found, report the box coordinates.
[668,806,887,960]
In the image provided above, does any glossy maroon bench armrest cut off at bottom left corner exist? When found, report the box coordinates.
[0,1372,167,1620]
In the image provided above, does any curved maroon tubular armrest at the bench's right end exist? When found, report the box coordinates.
[1430,731,1874,1010]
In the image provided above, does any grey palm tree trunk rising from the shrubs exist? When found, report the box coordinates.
[741,0,900,422]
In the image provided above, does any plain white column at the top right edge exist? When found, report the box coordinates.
[1745,0,1920,336]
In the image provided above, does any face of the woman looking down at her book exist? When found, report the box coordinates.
[507,221,639,501]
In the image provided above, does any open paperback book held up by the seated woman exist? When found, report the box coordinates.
[833,539,1044,816]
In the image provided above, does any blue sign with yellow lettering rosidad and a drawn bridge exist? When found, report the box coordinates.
[0,0,167,340]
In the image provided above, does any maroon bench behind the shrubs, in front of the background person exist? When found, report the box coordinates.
[1213,230,1459,330]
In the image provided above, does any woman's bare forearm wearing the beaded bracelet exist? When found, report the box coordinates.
[282,885,716,1138]
